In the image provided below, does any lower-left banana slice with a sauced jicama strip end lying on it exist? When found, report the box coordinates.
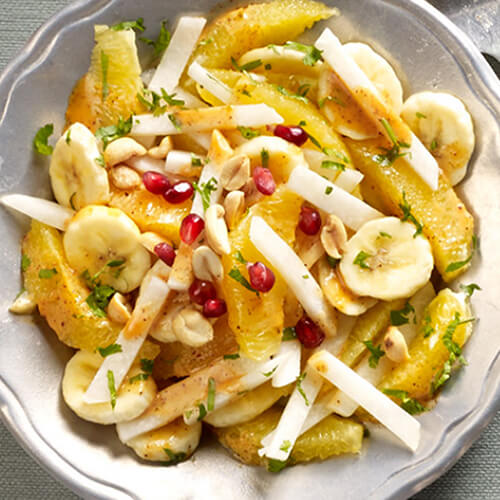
[62,351,157,425]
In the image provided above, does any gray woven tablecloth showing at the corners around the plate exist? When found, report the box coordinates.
[0,0,500,500]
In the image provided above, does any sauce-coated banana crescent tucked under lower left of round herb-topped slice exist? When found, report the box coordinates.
[317,259,377,316]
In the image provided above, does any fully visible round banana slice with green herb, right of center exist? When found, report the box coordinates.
[339,217,434,300]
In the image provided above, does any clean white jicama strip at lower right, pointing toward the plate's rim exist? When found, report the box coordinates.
[308,351,420,451]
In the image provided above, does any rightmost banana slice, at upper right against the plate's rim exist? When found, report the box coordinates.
[401,92,475,186]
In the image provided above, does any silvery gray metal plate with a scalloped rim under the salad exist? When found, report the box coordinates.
[0,0,500,500]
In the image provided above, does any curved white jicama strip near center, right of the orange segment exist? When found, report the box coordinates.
[250,216,335,336]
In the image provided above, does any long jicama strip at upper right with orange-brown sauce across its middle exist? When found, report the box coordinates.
[314,28,439,191]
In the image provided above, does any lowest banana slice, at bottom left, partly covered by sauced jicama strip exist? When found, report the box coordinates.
[124,418,202,464]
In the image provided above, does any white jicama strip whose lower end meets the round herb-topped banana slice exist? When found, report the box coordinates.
[287,167,383,231]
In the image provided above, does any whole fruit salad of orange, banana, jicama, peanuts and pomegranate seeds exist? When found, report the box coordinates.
[1,0,480,472]
